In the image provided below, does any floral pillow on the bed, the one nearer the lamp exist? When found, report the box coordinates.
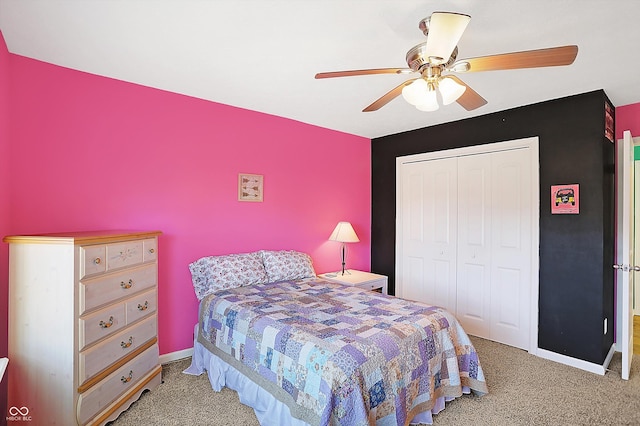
[260,250,316,283]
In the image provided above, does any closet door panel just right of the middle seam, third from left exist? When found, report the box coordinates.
[456,154,492,339]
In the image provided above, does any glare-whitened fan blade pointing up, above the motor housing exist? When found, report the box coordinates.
[420,12,471,64]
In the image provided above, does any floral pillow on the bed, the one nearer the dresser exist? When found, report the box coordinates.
[189,252,267,300]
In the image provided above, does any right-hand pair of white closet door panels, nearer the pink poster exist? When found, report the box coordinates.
[457,149,533,349]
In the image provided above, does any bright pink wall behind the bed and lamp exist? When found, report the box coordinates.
[3,55,371,354]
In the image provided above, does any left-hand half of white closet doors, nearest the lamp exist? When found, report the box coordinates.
[396,158,457,312]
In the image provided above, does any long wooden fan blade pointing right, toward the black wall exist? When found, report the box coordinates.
[451,45,578,72]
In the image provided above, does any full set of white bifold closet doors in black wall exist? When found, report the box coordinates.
[396,139,539,350]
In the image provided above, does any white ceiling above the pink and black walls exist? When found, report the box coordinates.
[0,0,640,138]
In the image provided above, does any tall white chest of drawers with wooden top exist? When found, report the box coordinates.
[3,231,162,425]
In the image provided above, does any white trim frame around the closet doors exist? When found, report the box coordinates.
[395,136,540,355]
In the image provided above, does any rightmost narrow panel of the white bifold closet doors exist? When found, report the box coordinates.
[491,149,532,349]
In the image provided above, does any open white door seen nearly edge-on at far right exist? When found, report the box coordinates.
[614,130,640,380]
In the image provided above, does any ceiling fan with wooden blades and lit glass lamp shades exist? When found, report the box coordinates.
[315,12,578,112]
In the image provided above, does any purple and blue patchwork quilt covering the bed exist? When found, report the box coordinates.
[198,279,487,426]
